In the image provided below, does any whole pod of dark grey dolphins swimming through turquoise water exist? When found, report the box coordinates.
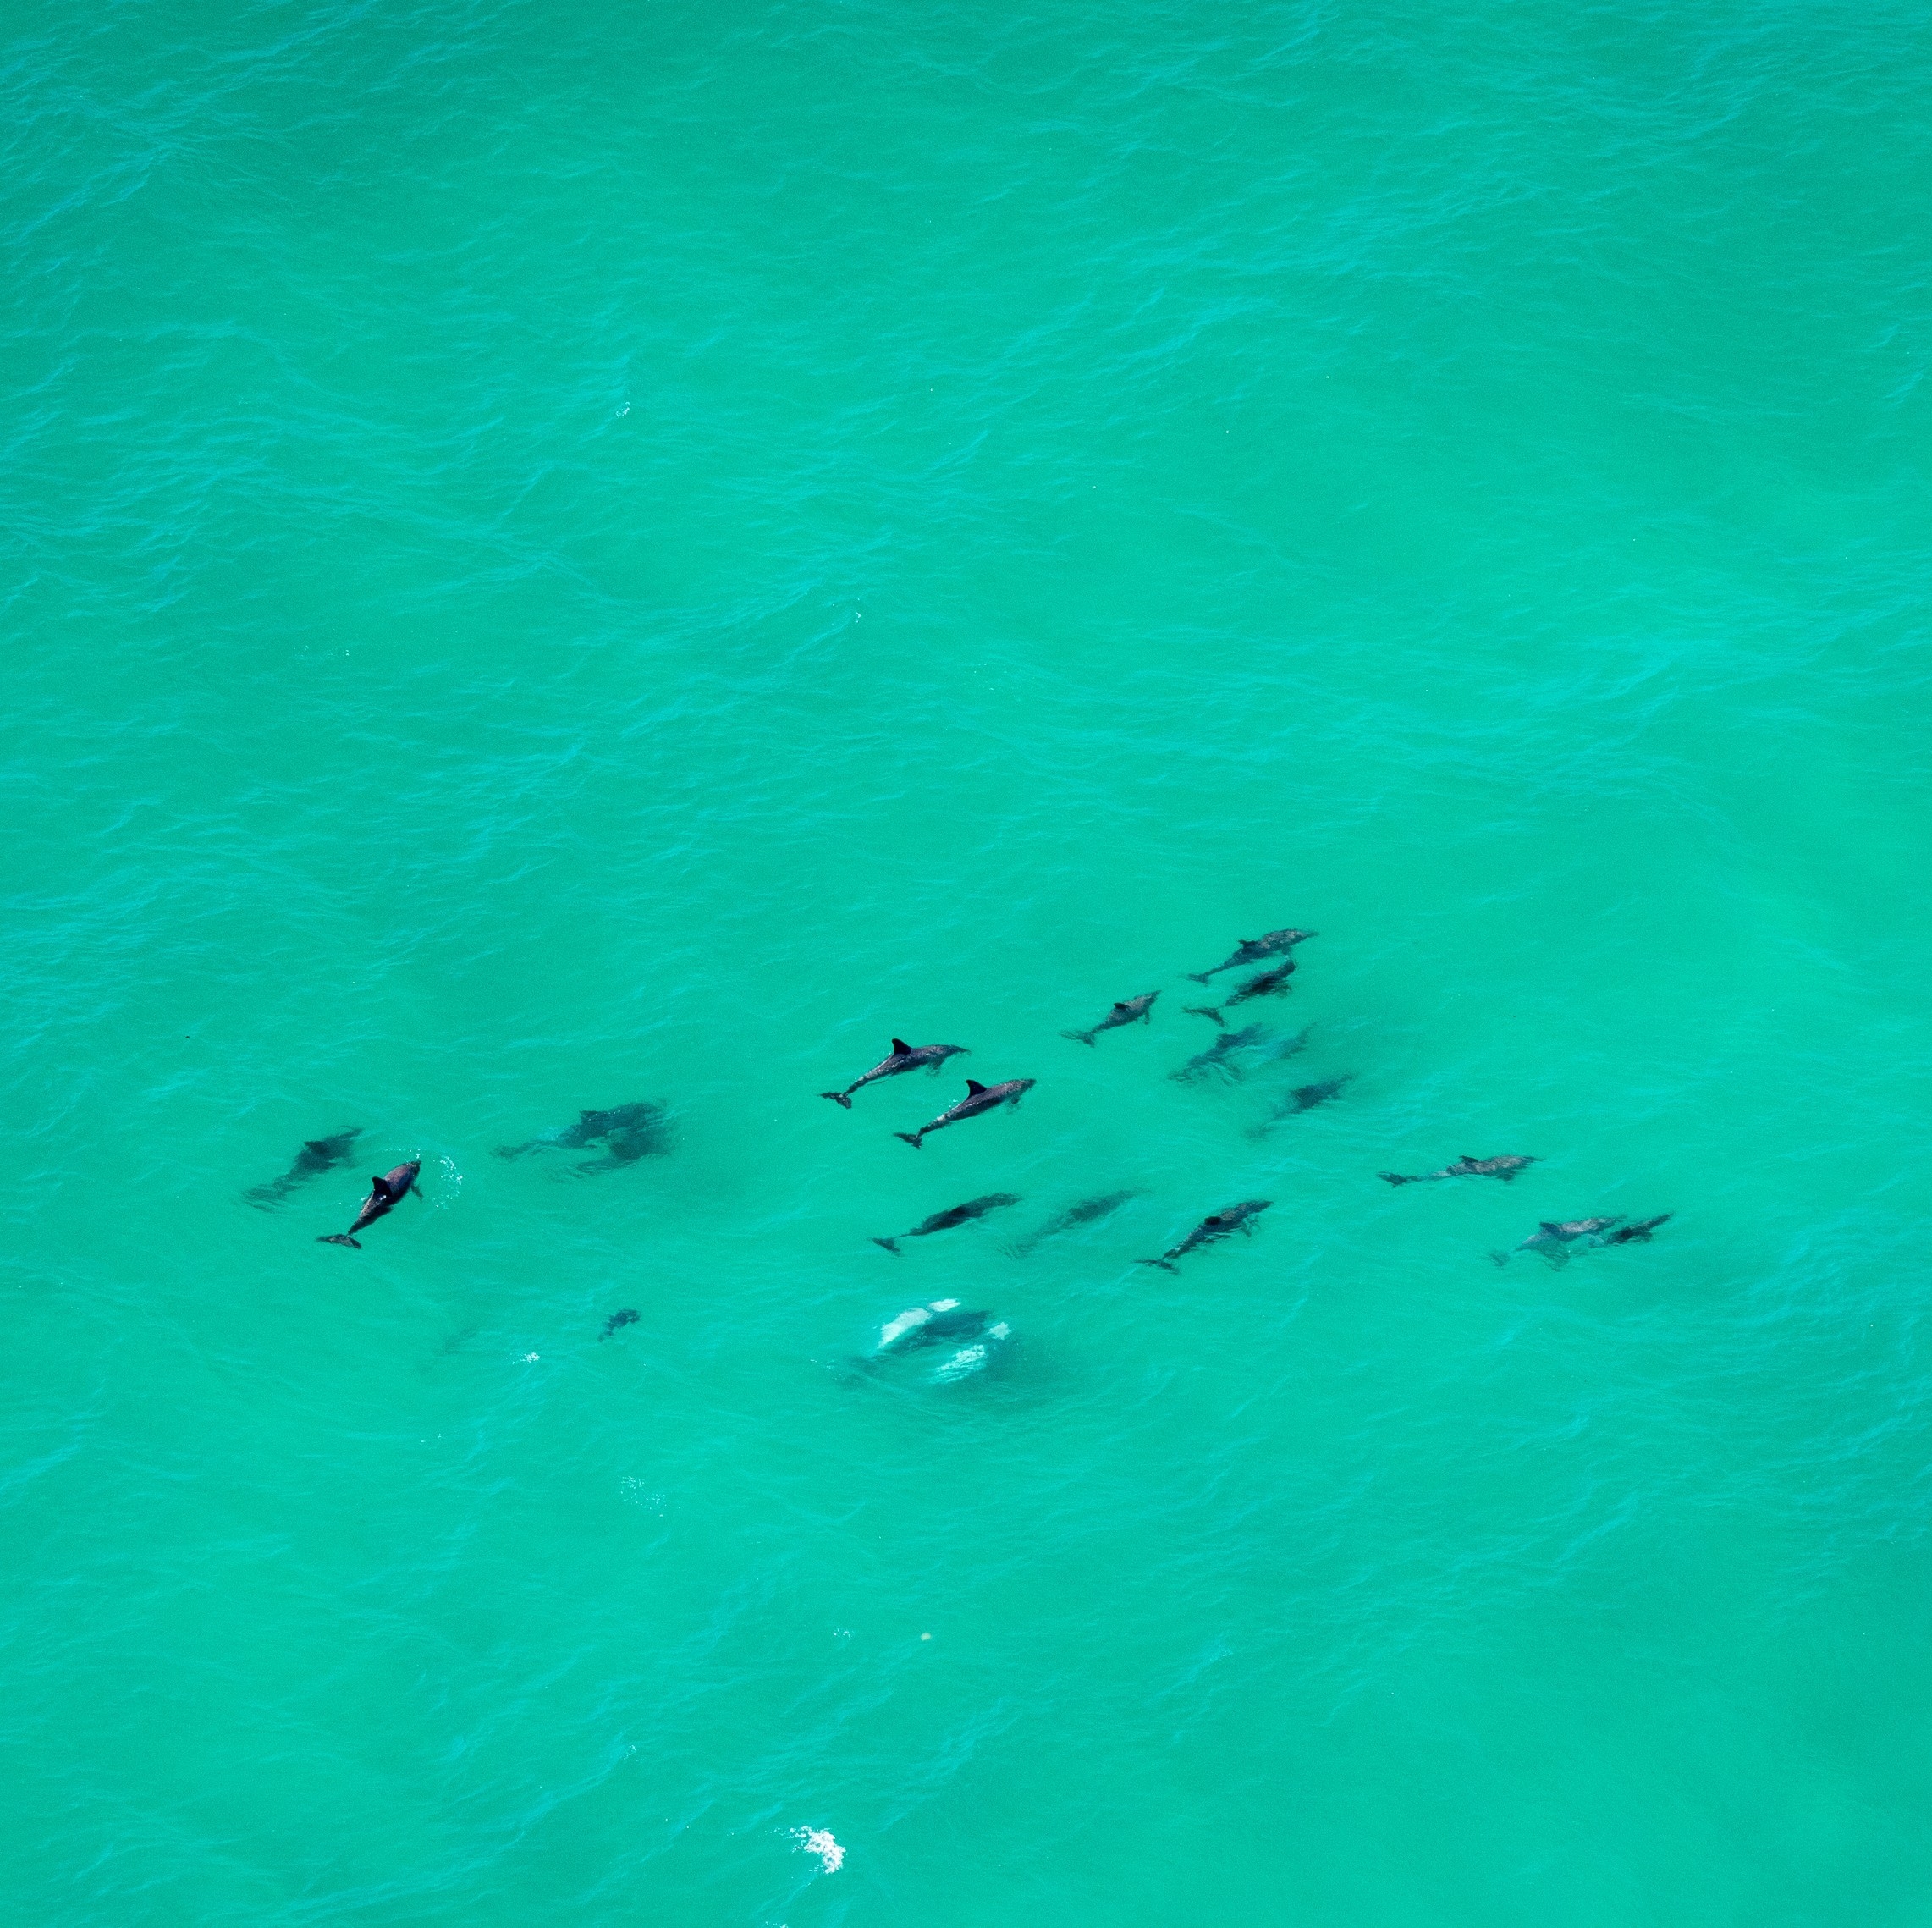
[241,928,1671,1383]
